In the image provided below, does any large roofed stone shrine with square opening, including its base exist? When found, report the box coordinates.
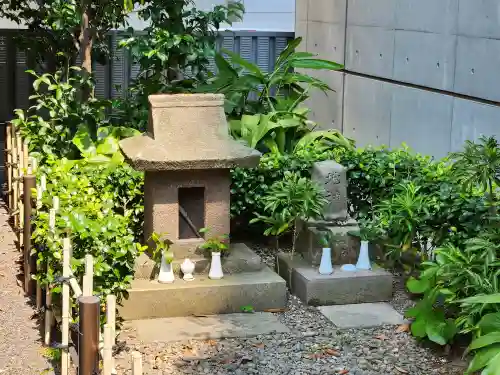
[116,94,286,319]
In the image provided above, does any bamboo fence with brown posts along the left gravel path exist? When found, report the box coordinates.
[4,124,143,375]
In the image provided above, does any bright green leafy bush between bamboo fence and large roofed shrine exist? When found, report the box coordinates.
[33,154,143,304]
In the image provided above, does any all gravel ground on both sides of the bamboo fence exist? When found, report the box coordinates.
[0,212,464,375]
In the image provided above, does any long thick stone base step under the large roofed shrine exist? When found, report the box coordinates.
[119,266,287,320]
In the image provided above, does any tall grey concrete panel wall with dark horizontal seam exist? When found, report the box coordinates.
[296,0,500,157]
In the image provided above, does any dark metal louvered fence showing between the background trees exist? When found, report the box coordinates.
[0,30,293,123]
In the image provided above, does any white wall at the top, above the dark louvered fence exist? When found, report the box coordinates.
[0,0,295,32]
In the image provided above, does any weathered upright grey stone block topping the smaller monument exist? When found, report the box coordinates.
[312,160,347,220]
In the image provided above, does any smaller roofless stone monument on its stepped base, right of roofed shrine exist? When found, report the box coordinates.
[277,160,392,305]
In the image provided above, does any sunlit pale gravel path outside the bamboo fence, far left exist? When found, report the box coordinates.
[0,206,51,375]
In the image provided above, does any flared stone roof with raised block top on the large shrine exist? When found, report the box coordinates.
[120,94,261,171]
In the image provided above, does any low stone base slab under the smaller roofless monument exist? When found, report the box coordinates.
[276,253,392,306]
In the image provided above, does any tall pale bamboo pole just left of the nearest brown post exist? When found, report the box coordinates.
[61,238,71,375]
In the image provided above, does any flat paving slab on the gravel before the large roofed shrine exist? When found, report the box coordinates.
[126,312,290,343]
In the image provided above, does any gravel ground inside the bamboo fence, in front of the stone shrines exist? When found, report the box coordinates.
[116,247,465,375]
